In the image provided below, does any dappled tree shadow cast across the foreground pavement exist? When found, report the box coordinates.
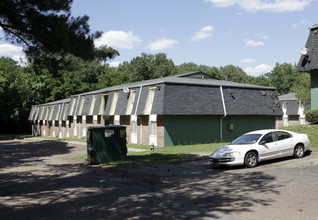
[0,140,279,219]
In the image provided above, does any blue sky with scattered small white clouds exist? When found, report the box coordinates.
[0,0,318,76]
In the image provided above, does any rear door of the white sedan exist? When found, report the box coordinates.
[275,131,294,156]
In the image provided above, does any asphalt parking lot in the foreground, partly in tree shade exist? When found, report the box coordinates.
[0,139,318,219]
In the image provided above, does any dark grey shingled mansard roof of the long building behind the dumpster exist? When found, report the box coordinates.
[29,72,282,120]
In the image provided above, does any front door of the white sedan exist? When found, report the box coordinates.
[259,132,280,160]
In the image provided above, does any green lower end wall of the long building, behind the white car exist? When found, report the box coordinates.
[164,115,276,146]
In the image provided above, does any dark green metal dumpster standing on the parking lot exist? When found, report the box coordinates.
[86,125,127,164]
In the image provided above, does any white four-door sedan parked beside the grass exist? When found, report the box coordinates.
[209,129,310,168]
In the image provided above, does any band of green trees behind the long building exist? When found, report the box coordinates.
[0,52,310,132]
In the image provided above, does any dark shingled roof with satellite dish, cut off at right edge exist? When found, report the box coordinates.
[296,24,318,72]
